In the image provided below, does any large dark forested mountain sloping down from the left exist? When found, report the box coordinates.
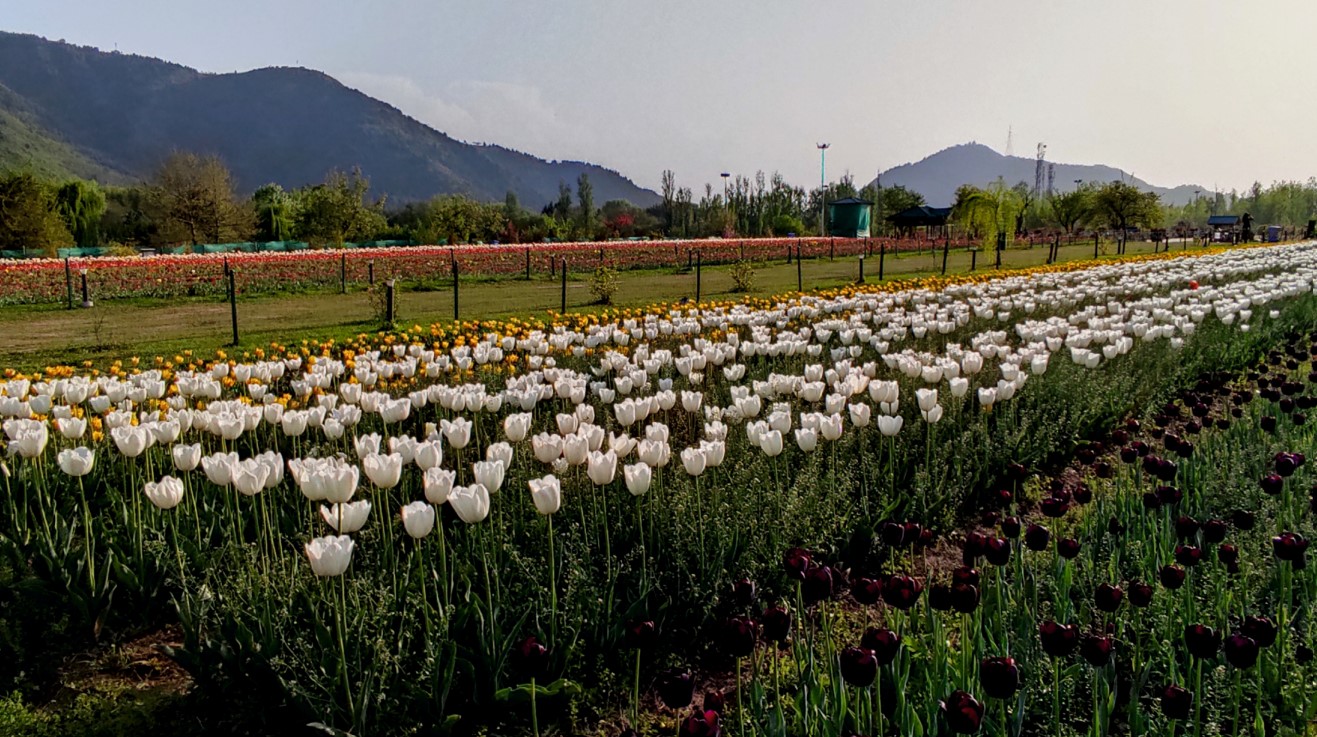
[0,32,660,208]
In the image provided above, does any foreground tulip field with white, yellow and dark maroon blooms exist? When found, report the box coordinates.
[0,242,1317,737]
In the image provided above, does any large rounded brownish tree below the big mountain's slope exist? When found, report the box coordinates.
[151,153,252,245]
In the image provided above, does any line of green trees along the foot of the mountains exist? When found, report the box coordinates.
[0,153,1317,253]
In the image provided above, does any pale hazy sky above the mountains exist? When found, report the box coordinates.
[0,0,1317,190]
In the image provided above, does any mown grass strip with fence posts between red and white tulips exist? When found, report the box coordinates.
[0,242,1195,370]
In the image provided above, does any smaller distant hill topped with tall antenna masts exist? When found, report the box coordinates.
[881,143,1208,207]
